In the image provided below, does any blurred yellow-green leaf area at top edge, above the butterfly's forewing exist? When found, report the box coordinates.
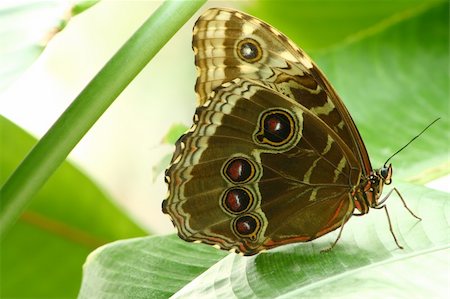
[250,0,443,53]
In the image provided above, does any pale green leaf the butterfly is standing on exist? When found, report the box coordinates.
[80,184,450,298]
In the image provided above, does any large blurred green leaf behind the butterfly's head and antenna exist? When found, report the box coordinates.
[313,3,450,182]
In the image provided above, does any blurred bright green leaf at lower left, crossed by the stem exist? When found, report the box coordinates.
[0,116,147,298]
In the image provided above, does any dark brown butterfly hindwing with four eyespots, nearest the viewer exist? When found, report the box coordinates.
[163,79,361,255]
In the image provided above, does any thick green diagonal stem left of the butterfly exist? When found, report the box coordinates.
[0,0,206,239]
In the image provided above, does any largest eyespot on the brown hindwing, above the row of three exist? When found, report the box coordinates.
[256,109,295,146]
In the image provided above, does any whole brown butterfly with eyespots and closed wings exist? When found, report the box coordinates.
[162,8,418,255]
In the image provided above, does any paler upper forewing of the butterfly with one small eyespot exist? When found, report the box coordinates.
[192,8,372,175]
